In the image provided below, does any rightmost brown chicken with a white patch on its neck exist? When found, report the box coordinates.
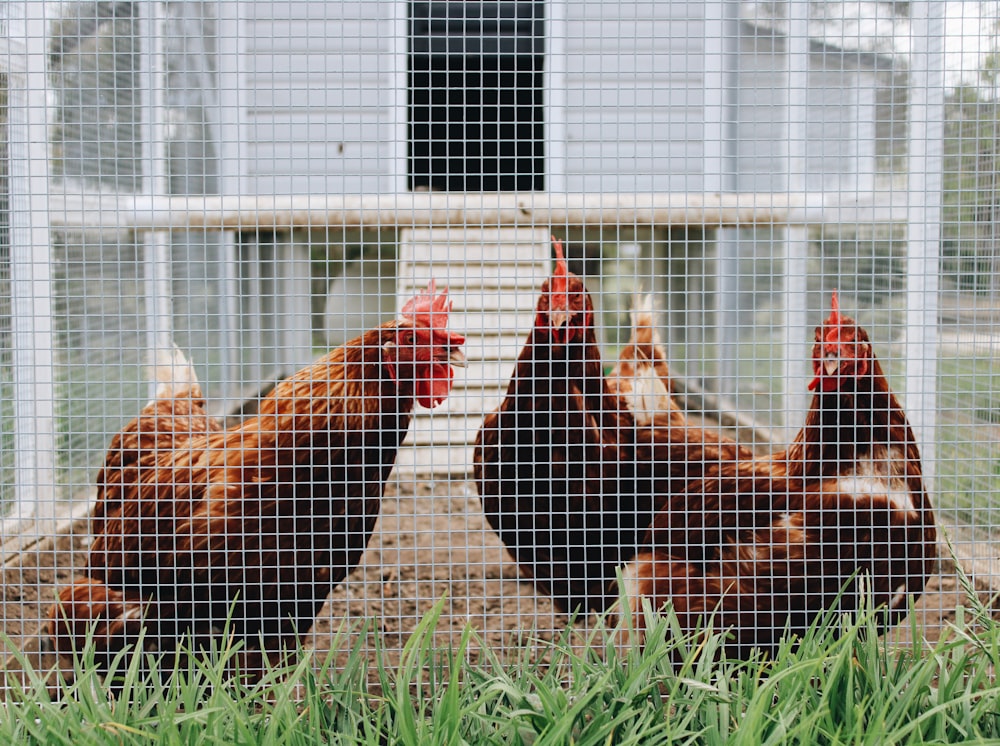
[623,294,937,659]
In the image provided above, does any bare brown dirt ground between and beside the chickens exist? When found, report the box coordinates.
[0,474,988,688]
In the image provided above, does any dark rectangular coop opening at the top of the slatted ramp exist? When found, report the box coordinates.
[408,0,545,192]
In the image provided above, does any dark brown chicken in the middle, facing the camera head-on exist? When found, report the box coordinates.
[473,243,749,611]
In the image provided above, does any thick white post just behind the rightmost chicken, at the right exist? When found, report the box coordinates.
[903,2,945,480]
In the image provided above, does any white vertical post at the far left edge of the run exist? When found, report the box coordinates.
[9,2,57,520]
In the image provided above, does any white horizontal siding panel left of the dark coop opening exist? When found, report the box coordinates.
[242,0,397,194]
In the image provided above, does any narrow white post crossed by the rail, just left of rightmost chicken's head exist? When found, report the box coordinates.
[782,0,812,441]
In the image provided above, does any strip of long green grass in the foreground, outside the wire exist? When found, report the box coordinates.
[0,586,1000,746]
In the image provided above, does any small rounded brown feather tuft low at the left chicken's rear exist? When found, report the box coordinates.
[48,579,148,668]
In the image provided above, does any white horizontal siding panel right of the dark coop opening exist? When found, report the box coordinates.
[559,0,711,192]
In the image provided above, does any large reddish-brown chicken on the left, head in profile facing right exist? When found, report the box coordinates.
[49,282,465,675]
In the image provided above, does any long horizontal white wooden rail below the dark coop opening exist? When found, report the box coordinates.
[49,192,907,232]
